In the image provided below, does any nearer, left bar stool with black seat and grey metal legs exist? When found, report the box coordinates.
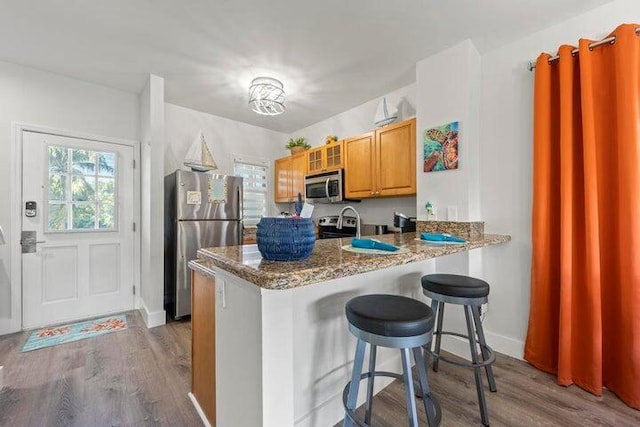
[342,295,442,427]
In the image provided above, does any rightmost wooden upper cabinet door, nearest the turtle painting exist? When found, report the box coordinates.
[376,119,416,196]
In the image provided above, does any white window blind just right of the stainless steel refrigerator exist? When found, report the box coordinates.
[233,159,269,226]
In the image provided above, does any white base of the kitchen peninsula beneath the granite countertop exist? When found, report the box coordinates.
[208,260,433,427]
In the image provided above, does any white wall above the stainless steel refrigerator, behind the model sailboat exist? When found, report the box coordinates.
[164,103,287,214]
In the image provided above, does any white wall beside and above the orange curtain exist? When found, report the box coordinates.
[480,0,640,357]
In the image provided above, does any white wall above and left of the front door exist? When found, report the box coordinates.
[0,61,138,334]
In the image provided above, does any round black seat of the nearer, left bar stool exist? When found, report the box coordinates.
[346,295,435,337]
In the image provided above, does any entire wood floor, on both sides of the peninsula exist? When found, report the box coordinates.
[0,312,640,427]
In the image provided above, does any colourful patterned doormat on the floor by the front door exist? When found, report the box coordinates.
[22,314,127,353]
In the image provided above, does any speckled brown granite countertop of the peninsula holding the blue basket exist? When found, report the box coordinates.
[190,233,511,289]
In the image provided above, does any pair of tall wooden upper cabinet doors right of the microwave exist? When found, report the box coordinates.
[344,119,416,199]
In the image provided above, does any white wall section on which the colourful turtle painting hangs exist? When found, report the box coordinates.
[416,40,484,355]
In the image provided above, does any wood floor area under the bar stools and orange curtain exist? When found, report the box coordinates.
[336,354,640,427]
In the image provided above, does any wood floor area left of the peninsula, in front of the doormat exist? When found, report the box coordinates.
[0,311,202,427]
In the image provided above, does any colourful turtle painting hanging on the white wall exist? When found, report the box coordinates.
[423,121,460,172]
